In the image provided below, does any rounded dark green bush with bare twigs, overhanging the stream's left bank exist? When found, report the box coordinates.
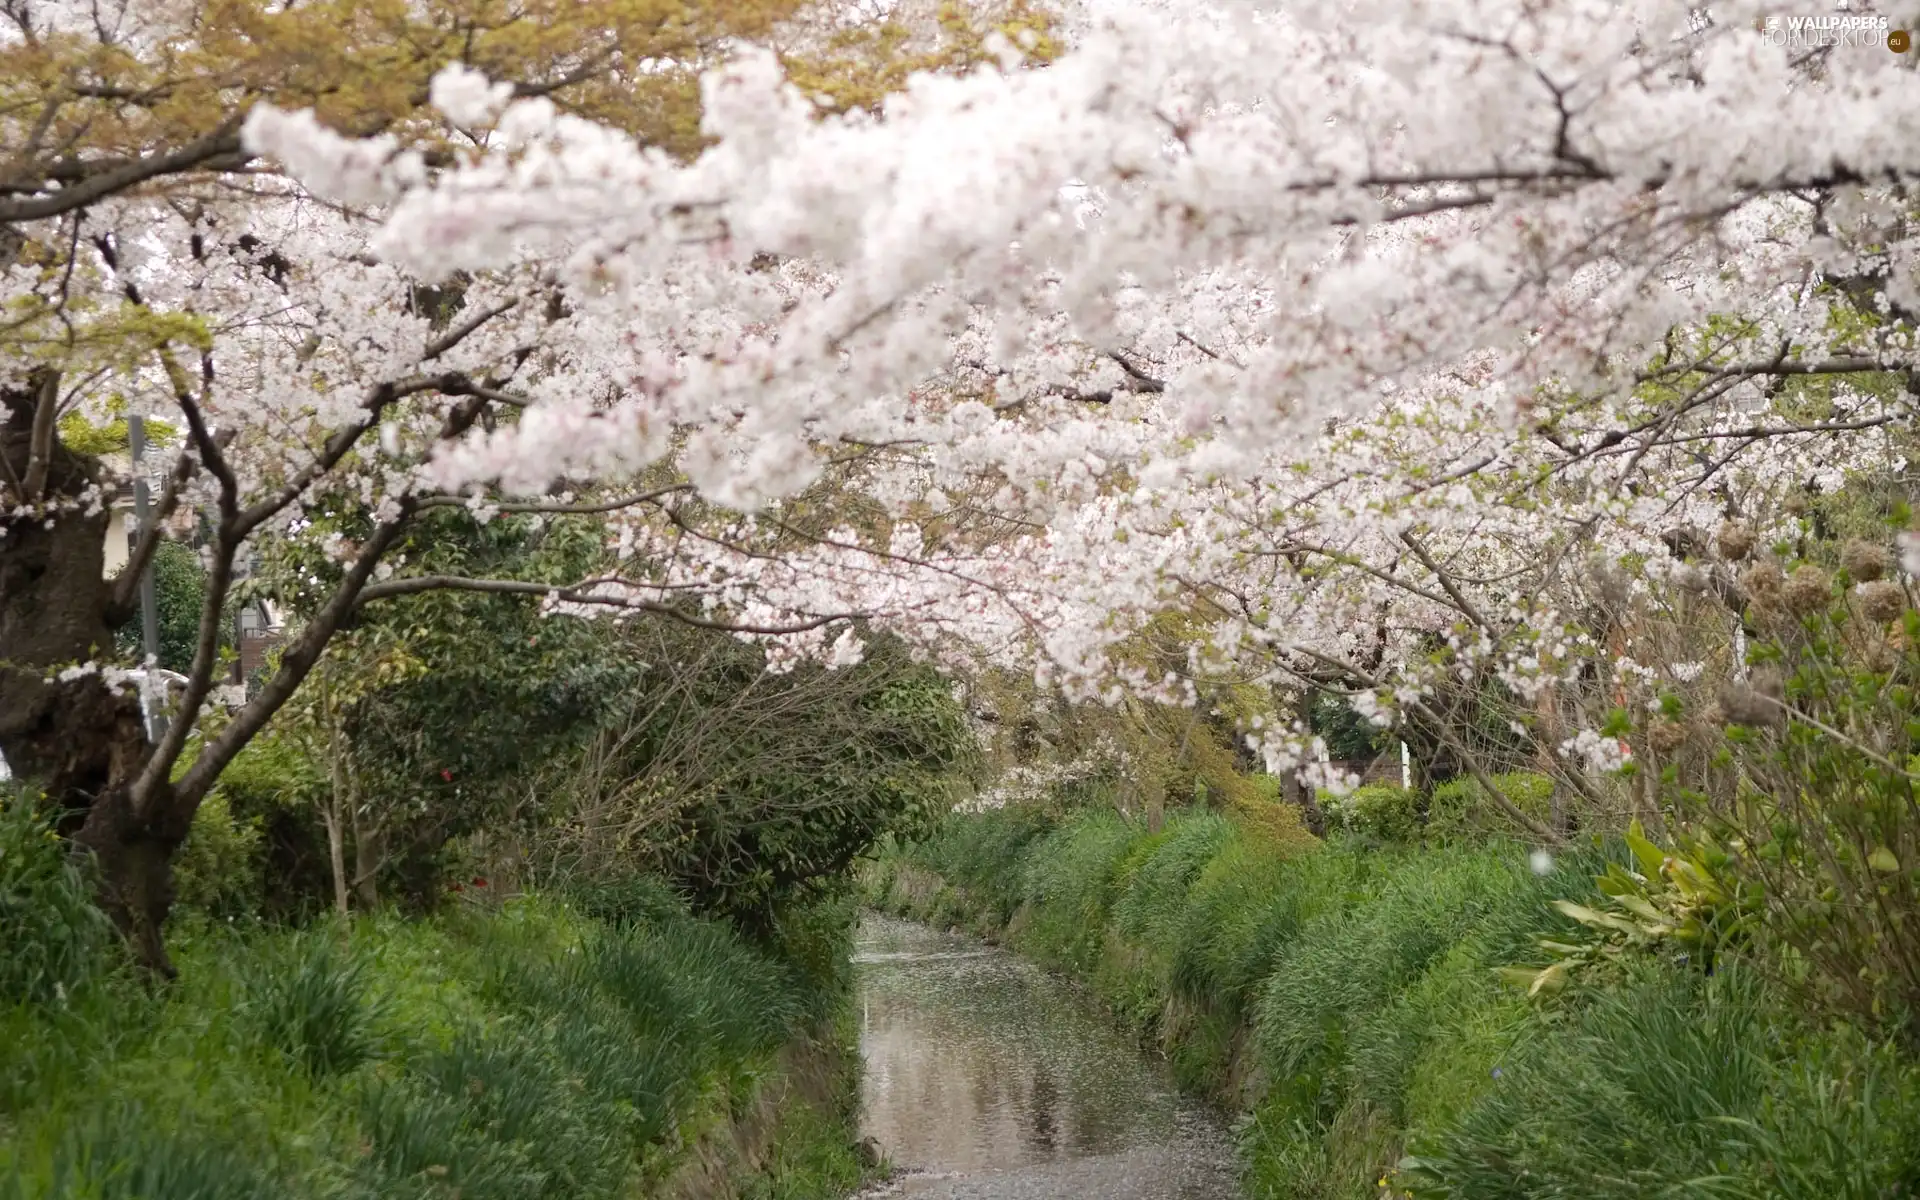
[543,628,975,921]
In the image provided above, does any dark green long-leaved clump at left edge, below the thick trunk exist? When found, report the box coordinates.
[0,783,117,1004]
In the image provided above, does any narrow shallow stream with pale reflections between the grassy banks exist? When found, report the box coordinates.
[854,916,1235,1200]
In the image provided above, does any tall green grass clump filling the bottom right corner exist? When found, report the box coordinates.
[1402,962,1920,1200]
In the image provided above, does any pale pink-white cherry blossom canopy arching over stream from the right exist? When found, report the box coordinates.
[244,0,1920,762]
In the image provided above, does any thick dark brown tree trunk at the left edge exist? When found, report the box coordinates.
[0,386,192,975]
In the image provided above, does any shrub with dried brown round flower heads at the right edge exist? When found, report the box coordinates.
[1643,572,1920,1029]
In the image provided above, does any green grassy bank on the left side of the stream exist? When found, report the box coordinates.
[0,794,862,1200]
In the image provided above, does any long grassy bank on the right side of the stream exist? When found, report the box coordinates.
[866,808,1920,1200]
